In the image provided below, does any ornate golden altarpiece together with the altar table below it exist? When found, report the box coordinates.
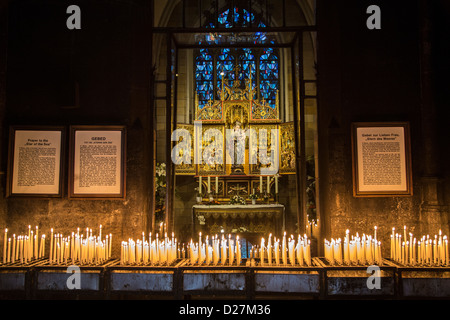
[175,79,296,234]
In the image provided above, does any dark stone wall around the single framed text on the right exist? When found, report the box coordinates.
[318,1,449,255]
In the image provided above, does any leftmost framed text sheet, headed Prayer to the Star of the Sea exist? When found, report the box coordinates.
[6,126,65,197]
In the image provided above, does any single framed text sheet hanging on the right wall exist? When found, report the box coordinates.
[352,122,412,197]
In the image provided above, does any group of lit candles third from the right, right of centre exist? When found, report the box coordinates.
[250,233,311,266]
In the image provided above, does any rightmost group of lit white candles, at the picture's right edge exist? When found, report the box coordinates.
[391,226,449,266]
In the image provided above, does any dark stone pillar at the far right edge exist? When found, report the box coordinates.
[419,0,448,234]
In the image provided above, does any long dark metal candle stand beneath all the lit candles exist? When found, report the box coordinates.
[0,257,450,299]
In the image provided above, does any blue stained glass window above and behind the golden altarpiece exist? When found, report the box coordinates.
[195,7,279,108]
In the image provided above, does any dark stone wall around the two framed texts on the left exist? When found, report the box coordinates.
[0,0,152,256]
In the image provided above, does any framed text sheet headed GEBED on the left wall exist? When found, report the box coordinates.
[69,126,126,199]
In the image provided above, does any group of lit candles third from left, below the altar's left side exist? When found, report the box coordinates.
[120,233,179,265]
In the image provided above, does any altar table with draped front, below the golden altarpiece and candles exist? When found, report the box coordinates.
[192,203,285,236]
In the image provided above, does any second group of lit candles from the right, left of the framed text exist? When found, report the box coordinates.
[324,227,383,265]
